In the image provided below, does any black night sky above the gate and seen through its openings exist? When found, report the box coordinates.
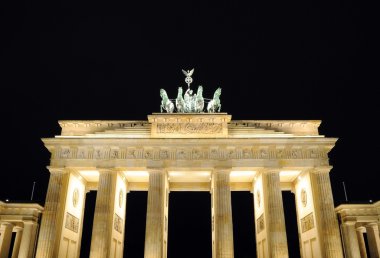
[0,0,374,258]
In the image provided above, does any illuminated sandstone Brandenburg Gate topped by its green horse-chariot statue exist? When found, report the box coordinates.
[36,70,343,258]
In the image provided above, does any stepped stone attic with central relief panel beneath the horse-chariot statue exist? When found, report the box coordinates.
[57,113,323,138]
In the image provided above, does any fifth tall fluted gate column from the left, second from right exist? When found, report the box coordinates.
[262,170,289,258]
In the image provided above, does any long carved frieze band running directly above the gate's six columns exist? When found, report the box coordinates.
[53,146,328,163]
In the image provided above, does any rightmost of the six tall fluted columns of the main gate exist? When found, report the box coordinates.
[310,167,343,258]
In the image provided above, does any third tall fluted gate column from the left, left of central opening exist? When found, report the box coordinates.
[144,169,166,258]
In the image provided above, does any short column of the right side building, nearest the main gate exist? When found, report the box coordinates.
[341,221,360,258]
